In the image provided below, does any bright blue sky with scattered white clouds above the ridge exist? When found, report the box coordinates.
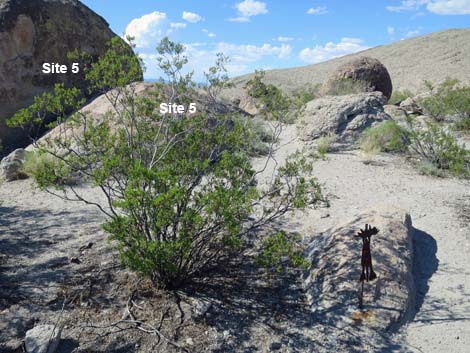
[82,0,470,80]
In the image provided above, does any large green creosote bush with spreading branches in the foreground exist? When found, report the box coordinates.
[9,38,323,289]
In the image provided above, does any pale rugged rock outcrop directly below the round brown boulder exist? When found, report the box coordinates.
[301,92,391,144]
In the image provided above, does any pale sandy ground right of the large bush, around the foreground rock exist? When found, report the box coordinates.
[258,126,470,353]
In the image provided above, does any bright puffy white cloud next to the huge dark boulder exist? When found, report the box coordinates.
[125,11,166,48]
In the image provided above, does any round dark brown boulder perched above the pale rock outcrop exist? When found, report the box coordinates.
[323,56,393,99]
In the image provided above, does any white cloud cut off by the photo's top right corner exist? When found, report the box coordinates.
[387,0,470,15]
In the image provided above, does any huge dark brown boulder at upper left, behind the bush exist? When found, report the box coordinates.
[0,0,140,150]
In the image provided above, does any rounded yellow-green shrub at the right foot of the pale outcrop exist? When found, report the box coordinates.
[359,120,407,153]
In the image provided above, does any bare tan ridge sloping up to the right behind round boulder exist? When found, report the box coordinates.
[227,28,470,97]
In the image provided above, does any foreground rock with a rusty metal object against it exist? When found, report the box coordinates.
[304,206,415,330]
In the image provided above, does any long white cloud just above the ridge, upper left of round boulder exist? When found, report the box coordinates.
[299,37,368,63]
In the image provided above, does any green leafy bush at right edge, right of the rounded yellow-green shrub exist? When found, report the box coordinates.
[407,118,469,177]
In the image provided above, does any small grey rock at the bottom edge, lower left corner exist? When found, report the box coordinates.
[25,325,61,353]
